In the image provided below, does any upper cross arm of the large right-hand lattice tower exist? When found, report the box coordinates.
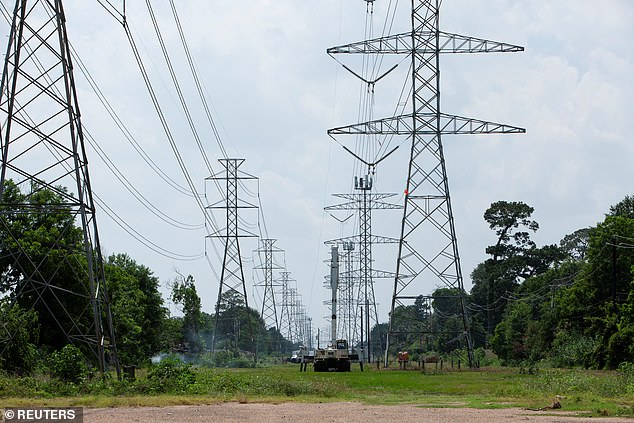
[326,31,524,54]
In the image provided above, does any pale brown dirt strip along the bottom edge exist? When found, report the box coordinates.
[84,402,634,423]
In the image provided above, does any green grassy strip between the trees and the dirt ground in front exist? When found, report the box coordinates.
[0,364,634,416]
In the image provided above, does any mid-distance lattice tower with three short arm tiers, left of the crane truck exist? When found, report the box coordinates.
[207,159,257,351]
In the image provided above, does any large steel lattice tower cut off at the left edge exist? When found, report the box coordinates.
[0,0,119,371]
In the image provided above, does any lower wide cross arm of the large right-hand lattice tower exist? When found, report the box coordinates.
[328,113,526,135]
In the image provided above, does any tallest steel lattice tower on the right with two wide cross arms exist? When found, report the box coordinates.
[328,0,525,365]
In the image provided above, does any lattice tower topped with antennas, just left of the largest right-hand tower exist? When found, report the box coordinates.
[325,175,402,362]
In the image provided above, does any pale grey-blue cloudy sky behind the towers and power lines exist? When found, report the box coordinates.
[1,0,634,336]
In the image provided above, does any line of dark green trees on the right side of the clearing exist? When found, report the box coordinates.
[376,196,634,368]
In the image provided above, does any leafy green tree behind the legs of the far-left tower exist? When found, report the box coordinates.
[0,180,94,349]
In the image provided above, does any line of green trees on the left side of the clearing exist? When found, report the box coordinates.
[0,180,294,373]
